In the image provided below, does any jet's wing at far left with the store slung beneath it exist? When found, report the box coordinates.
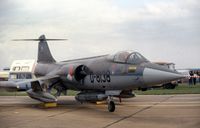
[0,75,61,102]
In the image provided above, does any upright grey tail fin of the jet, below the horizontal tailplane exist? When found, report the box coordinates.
[37,35,56,63]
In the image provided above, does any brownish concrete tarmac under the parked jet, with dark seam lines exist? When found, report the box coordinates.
[0,94,200,128]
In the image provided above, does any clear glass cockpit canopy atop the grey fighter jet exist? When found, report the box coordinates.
[112,51,148,64]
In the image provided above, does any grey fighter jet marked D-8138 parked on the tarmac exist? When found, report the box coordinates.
[0,35,184,112]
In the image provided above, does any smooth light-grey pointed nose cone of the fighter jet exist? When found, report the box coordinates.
[143,68,185,85]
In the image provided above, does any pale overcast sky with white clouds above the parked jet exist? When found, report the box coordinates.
[0,0,200,68]
